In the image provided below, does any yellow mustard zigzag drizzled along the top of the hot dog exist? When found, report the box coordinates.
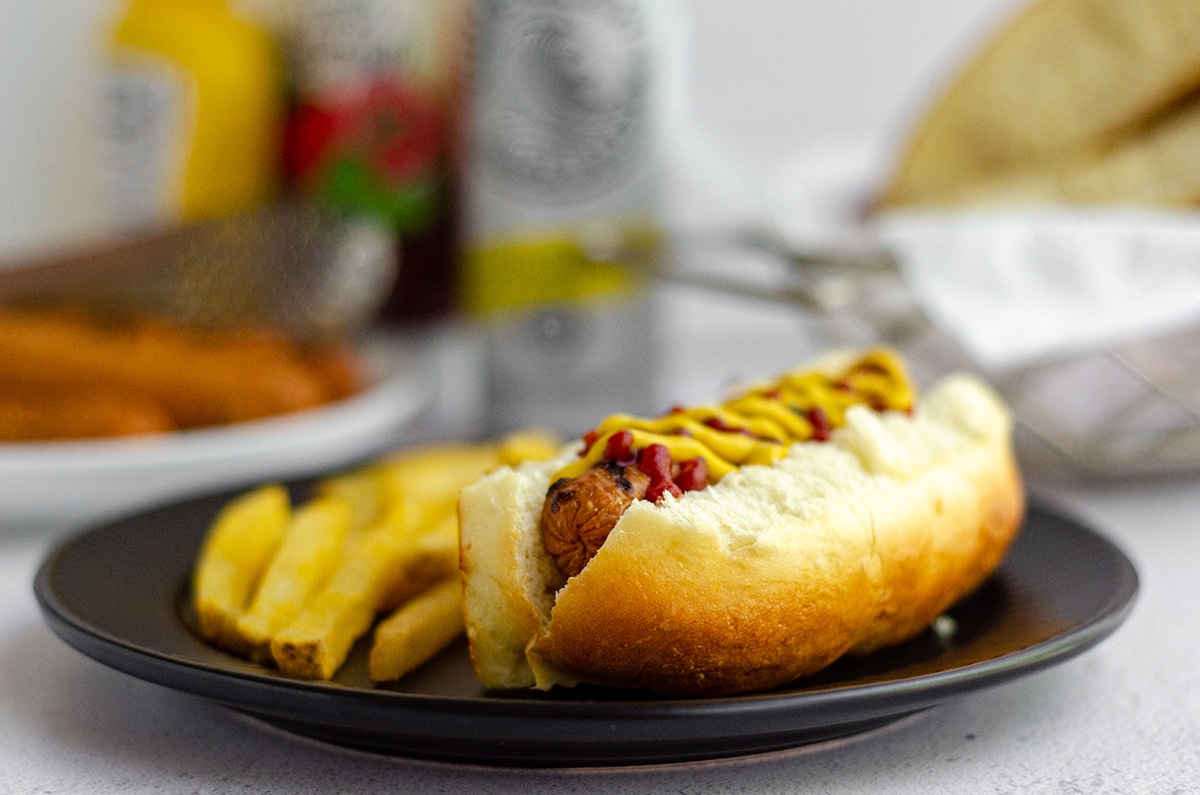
[553,348,916,483]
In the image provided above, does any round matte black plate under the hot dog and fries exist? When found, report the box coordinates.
[25,495,1138,766]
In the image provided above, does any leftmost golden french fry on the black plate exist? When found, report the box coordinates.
[192,484,292,652]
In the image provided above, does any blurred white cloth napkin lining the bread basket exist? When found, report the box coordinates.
[766,145,1200,370]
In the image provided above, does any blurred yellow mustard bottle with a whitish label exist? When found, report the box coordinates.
[104,0,284,227]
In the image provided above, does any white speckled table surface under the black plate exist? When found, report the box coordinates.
[0,288,1200,795]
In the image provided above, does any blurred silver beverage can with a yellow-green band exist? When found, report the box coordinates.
[462,0,665,434]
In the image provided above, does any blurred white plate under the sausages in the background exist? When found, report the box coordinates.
[0,337,433,533]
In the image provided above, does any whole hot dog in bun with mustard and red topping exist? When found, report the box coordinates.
[458,349,1025,695]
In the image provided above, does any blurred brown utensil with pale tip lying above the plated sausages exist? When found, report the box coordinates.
[0,202,398,339]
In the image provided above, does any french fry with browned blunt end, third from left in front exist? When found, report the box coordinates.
[271,525,410,679]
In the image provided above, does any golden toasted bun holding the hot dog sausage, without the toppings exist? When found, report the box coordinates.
[460,376,1025,695]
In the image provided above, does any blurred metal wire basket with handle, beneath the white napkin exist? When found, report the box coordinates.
[584,232,1200,478]
